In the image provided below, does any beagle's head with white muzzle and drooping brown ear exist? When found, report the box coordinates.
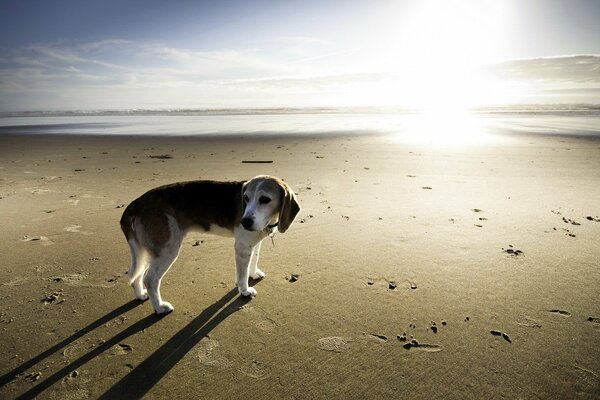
[241,175,300,233]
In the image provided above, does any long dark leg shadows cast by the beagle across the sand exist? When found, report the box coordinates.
[0,289,248,399]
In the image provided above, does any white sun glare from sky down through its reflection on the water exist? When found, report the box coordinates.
[378,0,508,145]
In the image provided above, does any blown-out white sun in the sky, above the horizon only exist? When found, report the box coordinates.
[384,0,509,111]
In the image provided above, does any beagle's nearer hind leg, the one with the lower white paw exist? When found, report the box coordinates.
[143,217,183,314]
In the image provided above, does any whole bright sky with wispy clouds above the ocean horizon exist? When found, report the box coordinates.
[0,0,600,111]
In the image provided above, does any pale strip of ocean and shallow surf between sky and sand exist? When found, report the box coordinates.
[0,105,600,143]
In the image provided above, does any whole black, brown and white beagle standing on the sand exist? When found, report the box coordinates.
[121,175,300,314]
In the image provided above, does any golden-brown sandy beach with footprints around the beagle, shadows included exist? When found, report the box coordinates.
[0,135,600,399]
